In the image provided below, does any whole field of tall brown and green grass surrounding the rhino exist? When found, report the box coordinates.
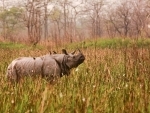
[0,39,150,113]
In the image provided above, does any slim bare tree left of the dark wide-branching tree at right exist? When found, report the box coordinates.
[85,0,105,37]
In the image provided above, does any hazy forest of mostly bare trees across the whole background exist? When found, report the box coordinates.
[0,0,150,44]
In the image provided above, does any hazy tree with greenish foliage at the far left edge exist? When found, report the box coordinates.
[0,7,22,39]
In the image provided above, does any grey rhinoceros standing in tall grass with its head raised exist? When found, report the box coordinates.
[6,49,85,82]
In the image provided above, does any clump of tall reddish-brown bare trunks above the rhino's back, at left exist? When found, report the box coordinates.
[24,0,41,45]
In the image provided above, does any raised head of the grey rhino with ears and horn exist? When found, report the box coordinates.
[62,49,85,69]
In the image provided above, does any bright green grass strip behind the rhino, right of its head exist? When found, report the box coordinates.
[66,38,150,48]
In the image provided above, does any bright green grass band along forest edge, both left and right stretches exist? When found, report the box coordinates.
[0,38,150,50]
